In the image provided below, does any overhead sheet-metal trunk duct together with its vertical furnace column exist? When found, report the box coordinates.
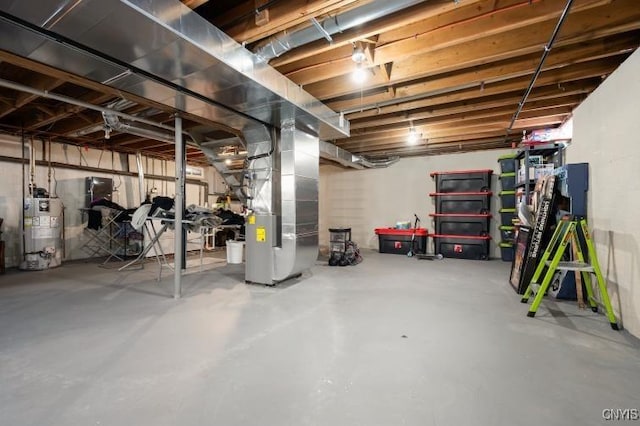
[0,0,349,284]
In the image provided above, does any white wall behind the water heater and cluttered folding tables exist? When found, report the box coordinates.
[0,136,218,267]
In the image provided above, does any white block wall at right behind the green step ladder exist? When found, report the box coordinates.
[566,50,640,337]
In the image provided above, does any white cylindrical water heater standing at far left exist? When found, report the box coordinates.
[20,198,64,271]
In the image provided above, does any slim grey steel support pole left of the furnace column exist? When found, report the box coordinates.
[173,115,186,299]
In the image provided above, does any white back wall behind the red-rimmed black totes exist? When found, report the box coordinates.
[319,150,512,258]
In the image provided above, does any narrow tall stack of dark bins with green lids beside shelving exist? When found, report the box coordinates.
[498,154,517,262]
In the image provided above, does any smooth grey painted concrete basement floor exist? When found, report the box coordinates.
[0,252,640,426]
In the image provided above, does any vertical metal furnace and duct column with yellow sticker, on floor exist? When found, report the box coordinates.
[245,120,319,285]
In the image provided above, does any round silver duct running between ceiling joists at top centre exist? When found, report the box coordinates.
[254,0,424,62]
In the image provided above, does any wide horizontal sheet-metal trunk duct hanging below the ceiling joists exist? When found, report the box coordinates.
[0,0,349,139]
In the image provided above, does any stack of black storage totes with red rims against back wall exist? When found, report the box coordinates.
[429,170,493,260]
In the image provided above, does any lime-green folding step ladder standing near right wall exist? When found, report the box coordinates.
[521,218,618,330]
